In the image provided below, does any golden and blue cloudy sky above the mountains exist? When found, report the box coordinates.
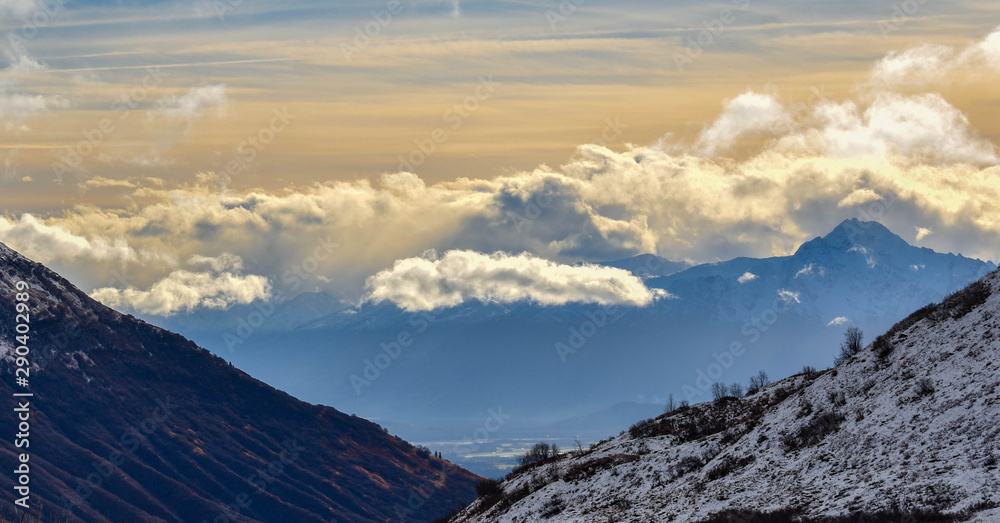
[0,0,1000,315]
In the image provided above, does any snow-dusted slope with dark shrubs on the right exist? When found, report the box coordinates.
[451,272,1000,523]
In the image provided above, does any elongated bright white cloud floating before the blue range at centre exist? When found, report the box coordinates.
[367,250,667,311]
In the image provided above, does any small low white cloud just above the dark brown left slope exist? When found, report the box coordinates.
[91,255,271,316]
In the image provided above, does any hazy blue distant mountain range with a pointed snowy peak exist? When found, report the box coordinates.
[156,220,996,452]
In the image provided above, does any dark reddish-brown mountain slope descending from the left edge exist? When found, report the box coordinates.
[0,244,479,523]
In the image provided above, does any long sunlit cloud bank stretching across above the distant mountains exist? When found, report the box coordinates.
[7,28,1000,308]
